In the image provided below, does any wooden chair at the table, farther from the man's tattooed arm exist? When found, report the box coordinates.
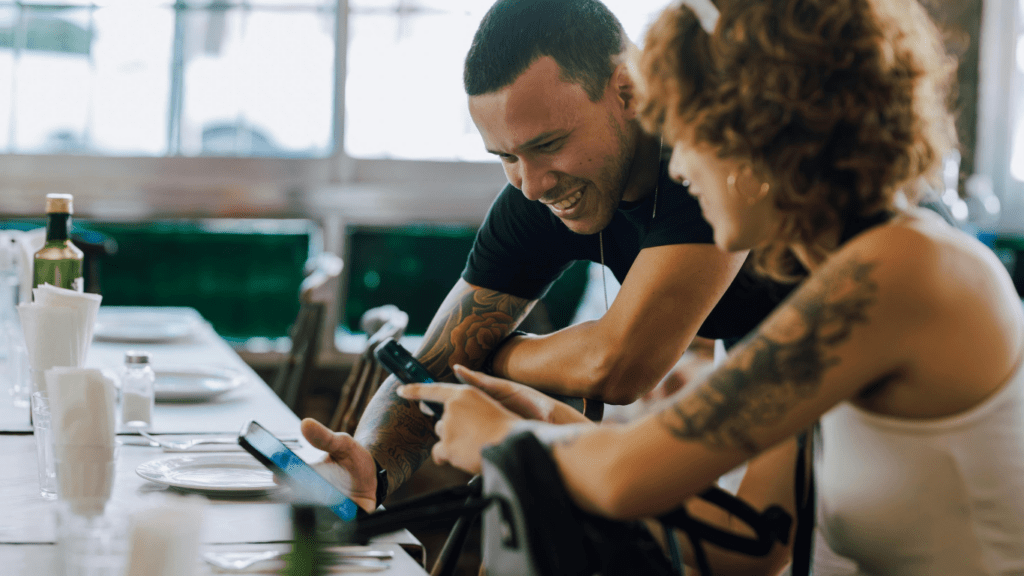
[270,252,343,413]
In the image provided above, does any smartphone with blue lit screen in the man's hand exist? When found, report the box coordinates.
[239,420,366,521]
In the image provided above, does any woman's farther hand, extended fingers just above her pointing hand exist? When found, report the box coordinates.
[454,365,587,424]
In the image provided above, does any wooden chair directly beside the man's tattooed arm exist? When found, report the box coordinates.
[328,304,409,434]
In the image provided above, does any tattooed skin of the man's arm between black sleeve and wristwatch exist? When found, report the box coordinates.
[355,281,536,490]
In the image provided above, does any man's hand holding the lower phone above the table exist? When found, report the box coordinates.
[302,418,377,512]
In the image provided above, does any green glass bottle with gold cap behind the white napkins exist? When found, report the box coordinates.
[32,194,85,292]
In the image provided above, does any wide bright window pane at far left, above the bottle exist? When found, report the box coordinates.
[0,0,336,157]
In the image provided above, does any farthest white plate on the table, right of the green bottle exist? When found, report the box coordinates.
[93,307,200,343]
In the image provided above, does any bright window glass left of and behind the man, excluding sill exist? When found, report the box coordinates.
[0,0,679,160]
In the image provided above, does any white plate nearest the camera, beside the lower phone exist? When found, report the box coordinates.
[135,452,284,494]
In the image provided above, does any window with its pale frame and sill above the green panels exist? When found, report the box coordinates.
[0,0,684,215]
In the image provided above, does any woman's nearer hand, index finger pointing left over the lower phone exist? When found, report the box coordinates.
[397,383,522,474]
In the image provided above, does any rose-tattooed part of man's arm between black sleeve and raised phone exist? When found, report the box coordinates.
[416,279,537,379]
